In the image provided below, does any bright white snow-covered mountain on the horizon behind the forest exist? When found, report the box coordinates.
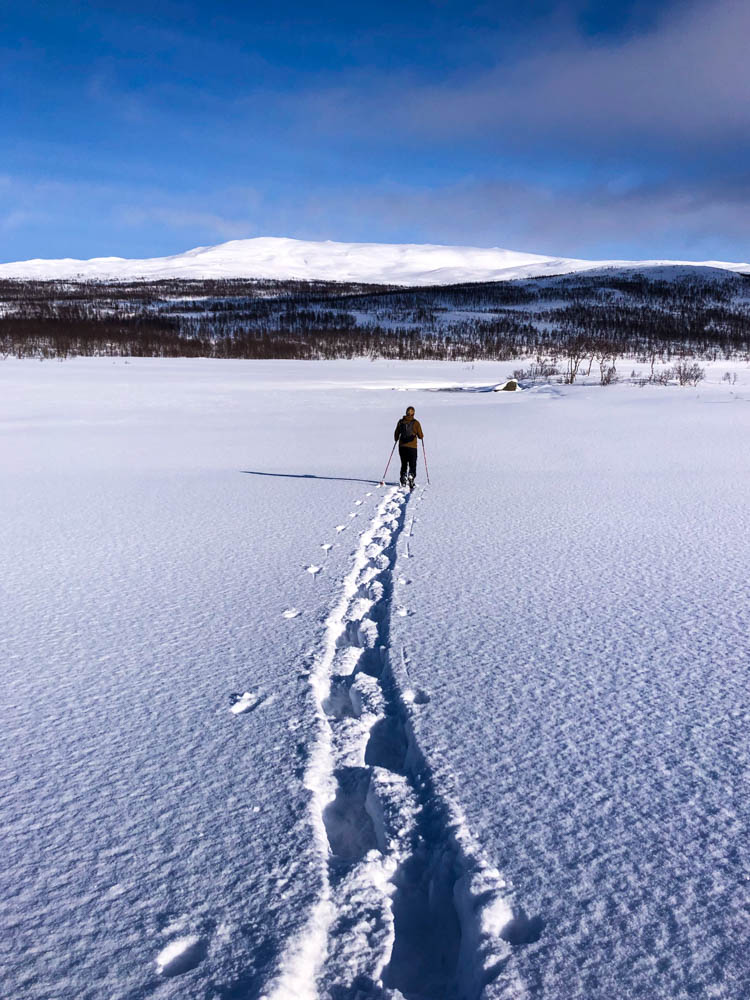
[0,237,750,285]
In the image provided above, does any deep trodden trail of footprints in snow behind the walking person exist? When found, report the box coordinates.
[272,488,528,1000]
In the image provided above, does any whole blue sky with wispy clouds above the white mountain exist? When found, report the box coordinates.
[0,0,750,261]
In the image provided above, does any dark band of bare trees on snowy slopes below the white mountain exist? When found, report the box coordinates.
[0,268,750,364]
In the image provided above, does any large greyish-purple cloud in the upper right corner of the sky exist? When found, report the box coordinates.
[274,0,750,154]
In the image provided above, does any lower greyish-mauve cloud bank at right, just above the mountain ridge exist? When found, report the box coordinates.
[270,176,750,260]
